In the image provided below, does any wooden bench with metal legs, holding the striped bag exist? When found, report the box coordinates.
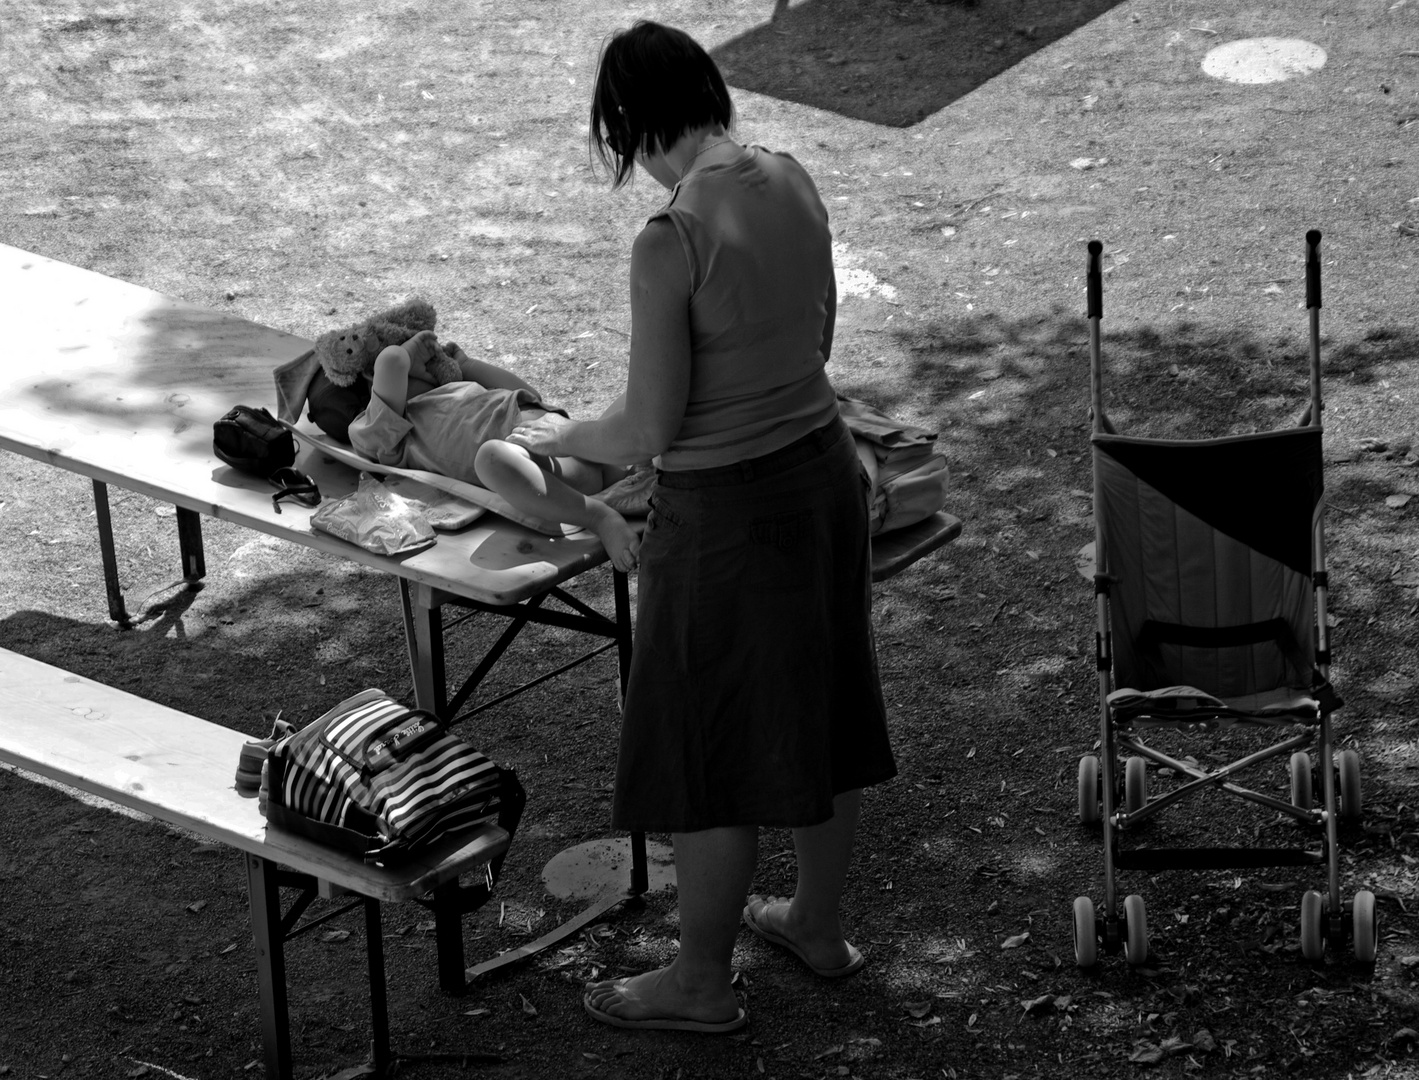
[0,649,521,1080]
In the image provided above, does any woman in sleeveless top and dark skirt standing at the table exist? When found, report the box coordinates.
[509,21,895,1032]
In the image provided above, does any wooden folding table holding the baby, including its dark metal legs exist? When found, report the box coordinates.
[0,244,632,992]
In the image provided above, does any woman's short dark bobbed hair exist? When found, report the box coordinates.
[589,18,734,187]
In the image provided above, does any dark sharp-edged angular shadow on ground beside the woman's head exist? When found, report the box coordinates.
[711,0,1120,128]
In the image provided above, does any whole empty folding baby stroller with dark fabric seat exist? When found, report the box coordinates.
[1074,230,1376,968]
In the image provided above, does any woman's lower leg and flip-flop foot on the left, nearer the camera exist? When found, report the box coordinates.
[587,826,759,1023]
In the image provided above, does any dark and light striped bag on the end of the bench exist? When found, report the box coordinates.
[261,690,521,863]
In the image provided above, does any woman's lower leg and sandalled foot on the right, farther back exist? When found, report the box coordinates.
[749,789,863,971]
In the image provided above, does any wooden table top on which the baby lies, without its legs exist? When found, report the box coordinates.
[0,244,607,605]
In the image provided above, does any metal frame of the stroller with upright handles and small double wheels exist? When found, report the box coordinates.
[1074,230,1378,968]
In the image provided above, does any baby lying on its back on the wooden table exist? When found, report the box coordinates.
[349,331,640,571]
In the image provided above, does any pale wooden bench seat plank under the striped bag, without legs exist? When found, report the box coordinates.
[0,649,508,901]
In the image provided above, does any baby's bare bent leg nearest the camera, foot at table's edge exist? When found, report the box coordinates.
[474,439,640,571]
